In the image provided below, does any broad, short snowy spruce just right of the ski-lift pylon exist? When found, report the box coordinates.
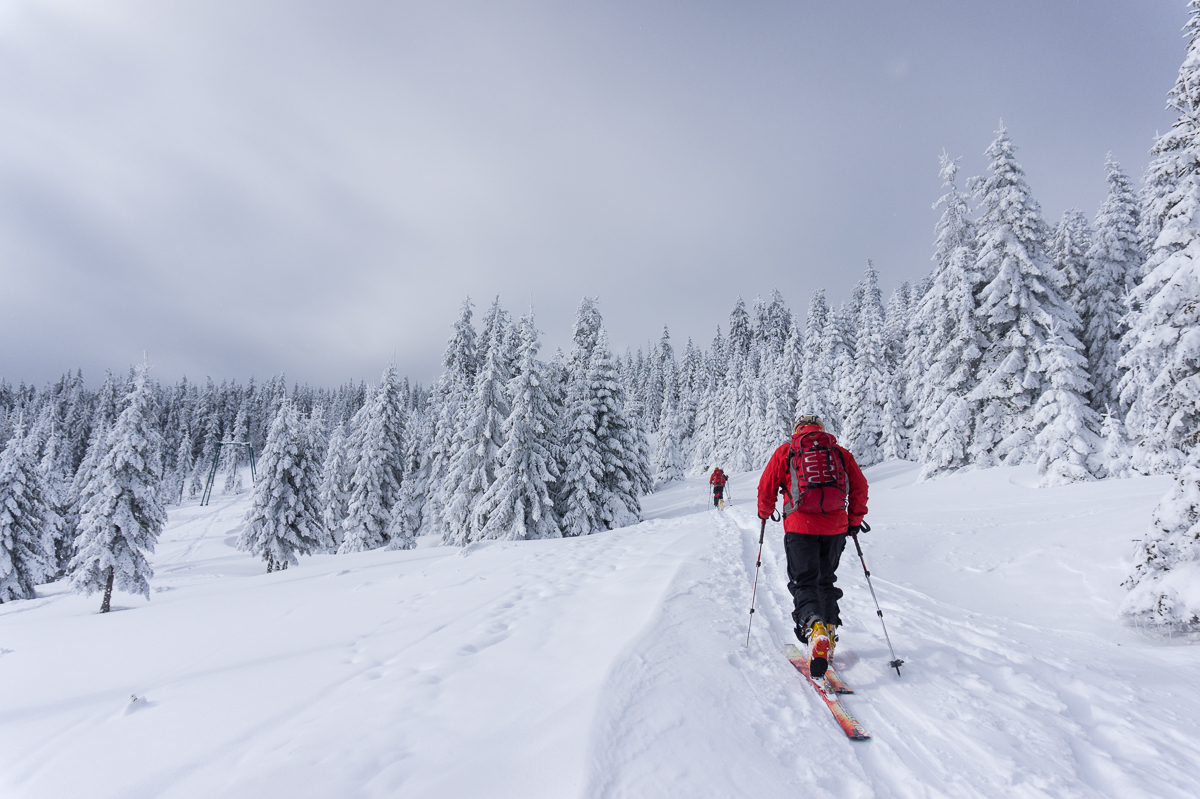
[238,401,332,572]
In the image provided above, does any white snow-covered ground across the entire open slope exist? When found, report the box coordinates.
[0,463,1200,799]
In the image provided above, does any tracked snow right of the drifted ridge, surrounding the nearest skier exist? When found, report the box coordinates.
[588,464,1200,797]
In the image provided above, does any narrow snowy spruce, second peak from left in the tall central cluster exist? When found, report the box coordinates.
[442,307,512,547]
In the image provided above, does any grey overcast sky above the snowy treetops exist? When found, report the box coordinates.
[0,0,1187,385]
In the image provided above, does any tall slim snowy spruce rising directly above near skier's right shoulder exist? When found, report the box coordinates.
[841,260,892,465]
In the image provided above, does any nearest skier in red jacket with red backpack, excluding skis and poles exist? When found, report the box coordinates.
[758,416,866,678]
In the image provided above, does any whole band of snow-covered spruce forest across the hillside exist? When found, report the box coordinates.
[7,4,1200,624]
